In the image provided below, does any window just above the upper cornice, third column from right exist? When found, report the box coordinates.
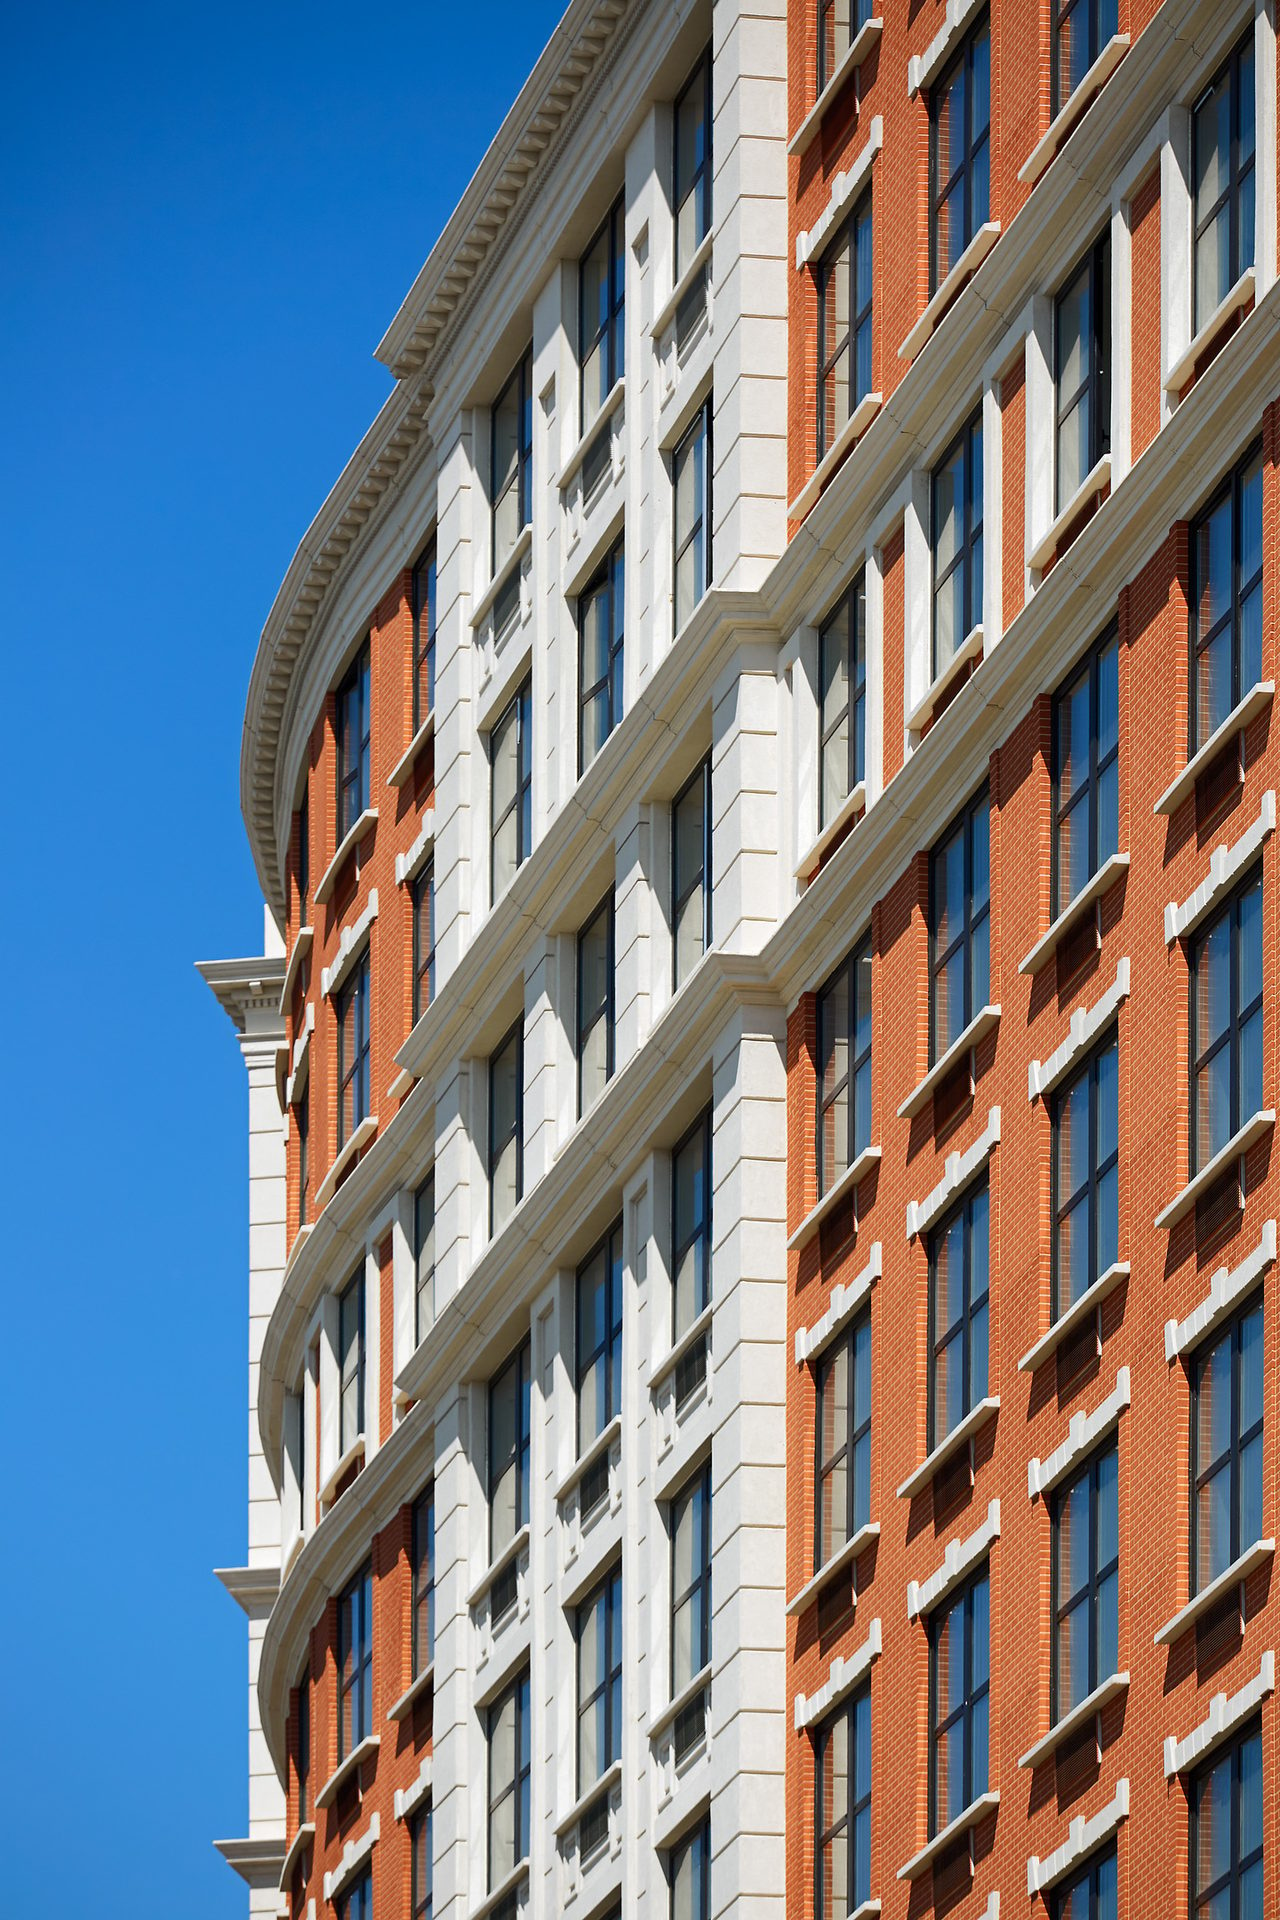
[929,21,990,294]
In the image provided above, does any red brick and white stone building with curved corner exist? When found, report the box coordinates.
[205,0,1280,1920]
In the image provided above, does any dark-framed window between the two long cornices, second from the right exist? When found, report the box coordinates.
[1054,234,1111,513]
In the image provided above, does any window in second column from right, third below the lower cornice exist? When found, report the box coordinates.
[1052,1446,1121,1720]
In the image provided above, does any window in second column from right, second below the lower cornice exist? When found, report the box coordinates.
[1052,1035,1121,1319]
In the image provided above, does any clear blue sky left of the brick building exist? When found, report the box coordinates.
[0,0,560,1920]
